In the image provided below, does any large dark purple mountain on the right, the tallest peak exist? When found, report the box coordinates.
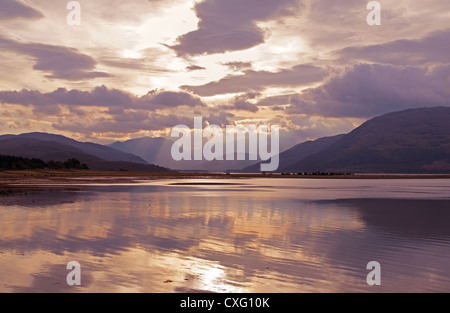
[282,107,450,174]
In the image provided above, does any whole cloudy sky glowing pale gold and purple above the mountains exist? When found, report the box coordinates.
[0,0,450,149]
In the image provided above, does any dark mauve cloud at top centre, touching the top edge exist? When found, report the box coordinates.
[172,0,298,56]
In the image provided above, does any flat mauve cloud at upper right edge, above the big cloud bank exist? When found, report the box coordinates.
[339,29,450,65]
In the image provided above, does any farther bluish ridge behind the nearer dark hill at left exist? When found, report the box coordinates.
[0,133,147,164]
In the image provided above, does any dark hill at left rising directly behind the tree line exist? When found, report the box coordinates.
[0,134,167,172]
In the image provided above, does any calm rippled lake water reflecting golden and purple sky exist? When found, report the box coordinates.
[0,179,450,293]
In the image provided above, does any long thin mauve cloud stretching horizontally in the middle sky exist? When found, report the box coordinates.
[181,65,327,97]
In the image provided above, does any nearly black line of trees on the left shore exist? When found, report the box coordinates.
[0,155,89,170]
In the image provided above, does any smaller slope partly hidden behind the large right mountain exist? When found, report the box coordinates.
[242,135,344,173]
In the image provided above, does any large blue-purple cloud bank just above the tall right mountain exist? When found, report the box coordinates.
[286,64,450,118]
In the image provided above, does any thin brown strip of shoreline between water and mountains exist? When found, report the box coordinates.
[0,170,450,194]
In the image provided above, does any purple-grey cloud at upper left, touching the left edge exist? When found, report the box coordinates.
[0,37,109,80]
